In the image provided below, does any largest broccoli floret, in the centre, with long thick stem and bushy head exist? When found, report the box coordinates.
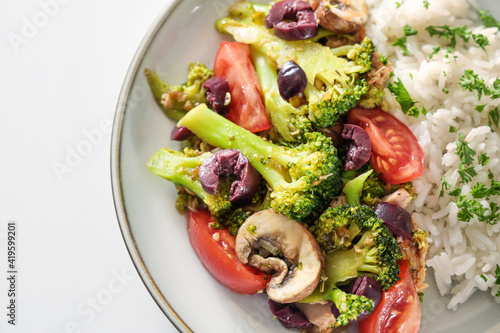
[177,104,342,222]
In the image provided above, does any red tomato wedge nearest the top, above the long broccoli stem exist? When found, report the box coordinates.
[214,41,271,133]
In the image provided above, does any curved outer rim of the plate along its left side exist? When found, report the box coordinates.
[110,0,193,332]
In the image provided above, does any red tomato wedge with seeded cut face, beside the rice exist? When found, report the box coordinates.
[347,108,424,184]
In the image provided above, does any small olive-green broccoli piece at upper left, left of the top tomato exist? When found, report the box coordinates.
[144,62,213,120]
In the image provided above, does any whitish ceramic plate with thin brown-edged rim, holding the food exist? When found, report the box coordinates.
[111,0,500,333]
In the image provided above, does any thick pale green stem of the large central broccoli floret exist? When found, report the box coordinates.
[177,104,294,189]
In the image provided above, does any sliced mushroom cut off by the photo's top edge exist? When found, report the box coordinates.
[309,0,368,34]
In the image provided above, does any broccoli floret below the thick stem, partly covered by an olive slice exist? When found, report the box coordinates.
[148,148,250,235]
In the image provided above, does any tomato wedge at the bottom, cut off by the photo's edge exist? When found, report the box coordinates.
[359,260,421,333]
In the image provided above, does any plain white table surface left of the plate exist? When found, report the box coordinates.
[0,0,177,333]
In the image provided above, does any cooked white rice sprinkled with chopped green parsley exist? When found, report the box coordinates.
[367,0,500,309]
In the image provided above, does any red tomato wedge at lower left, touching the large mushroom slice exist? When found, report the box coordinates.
[188,210,269,294]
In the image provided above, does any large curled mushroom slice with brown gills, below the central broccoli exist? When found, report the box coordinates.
[235,210,325,303]
